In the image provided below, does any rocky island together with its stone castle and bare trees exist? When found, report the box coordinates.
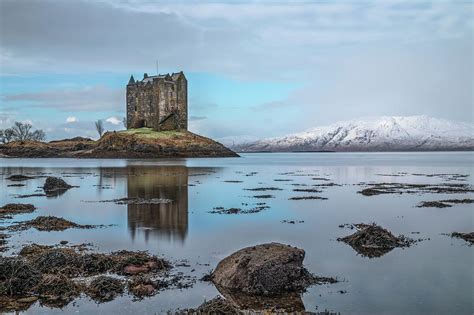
[0,71,239,159]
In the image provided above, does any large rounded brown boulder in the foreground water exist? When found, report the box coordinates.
[212,243,315,295]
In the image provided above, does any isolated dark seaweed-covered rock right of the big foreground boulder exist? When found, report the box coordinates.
[337,224,414,258]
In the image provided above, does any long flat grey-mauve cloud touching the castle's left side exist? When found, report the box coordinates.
[3,85,125,112]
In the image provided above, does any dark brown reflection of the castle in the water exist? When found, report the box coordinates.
[127,166,188,241]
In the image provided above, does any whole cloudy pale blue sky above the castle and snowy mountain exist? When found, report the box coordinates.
[0,0,474,140]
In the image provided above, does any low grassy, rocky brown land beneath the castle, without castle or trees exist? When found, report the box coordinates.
[0,128,239,159]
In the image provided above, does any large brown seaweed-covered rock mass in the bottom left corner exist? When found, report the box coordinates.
[0,244,173,312]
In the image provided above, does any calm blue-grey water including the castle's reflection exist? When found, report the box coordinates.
[0,153,474,314]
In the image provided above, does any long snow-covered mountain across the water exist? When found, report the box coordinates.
[232,116,474,152]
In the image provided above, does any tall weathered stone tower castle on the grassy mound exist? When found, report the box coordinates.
[127,71,188,131]
